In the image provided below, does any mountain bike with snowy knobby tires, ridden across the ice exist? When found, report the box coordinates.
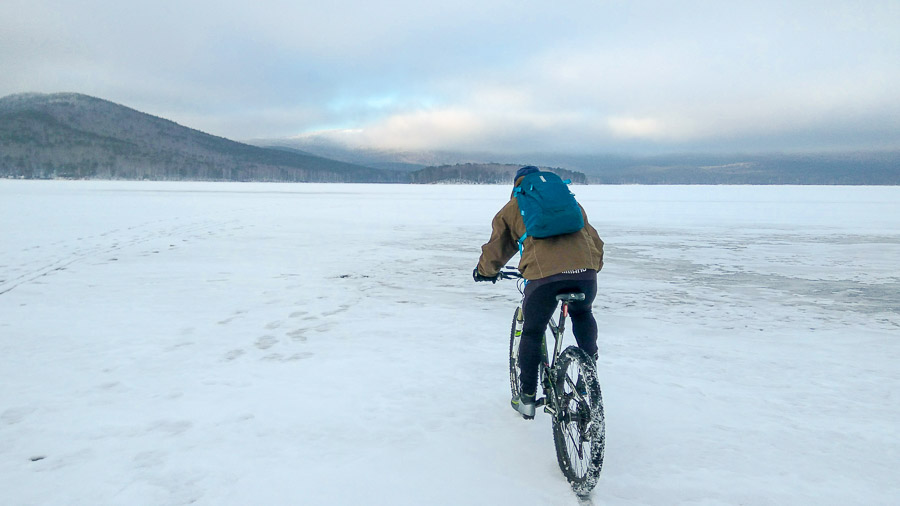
[500,266,606,497]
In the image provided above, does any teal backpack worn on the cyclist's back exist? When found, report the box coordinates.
[513,171,584,254]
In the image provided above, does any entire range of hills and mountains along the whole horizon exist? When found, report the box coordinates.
[0,93,900,185]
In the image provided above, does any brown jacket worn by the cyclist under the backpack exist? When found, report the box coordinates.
[478,185,603,279]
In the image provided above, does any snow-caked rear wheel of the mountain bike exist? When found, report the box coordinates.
[553,346,606,496]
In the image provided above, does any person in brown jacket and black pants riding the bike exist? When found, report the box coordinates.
[472,165,603,417]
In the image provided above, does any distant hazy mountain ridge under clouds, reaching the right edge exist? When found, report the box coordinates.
[254,136,900,185]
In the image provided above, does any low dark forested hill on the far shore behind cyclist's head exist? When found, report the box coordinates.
[410,163,587,184]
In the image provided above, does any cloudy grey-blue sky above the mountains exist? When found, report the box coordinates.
[0,0,900,153]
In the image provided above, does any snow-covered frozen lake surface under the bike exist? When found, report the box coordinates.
[0,180,900,505]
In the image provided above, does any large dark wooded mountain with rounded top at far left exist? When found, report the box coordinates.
[0,93,400,182]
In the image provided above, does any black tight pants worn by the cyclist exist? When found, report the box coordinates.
[519,270,597,394]
